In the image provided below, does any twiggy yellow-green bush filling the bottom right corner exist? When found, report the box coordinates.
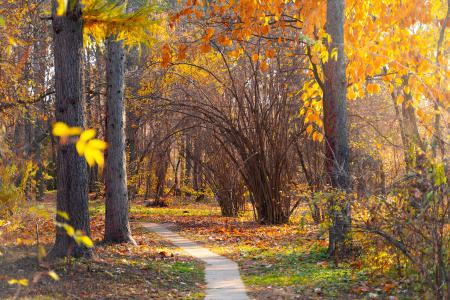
[354,160,450,299]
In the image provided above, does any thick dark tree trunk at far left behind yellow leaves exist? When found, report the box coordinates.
[49,0,92,257]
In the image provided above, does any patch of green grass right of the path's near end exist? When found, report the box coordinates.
[240,247,364,297]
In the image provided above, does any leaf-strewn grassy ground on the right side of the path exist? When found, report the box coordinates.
[131,200,414,300]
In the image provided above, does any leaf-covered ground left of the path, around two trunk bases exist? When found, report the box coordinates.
[0,193,205,299]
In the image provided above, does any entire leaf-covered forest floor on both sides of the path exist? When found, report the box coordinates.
[0,193,413,299]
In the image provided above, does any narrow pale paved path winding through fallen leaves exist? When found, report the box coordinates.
[142,223,249,300]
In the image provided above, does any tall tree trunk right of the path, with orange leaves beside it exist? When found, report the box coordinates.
[323,0,351,257]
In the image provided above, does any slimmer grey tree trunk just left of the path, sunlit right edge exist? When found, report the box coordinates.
[104,37,134,243]
